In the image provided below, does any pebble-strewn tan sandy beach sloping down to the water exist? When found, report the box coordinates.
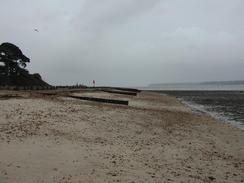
[0,92,244,183]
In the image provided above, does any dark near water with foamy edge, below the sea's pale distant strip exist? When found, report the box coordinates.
[156,91,244,131]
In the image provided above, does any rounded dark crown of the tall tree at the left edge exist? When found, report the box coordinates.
[0,43,30,76]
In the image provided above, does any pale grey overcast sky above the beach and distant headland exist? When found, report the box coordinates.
[0,0,244,86]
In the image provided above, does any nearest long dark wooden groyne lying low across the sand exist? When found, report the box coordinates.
[68,95,129,105]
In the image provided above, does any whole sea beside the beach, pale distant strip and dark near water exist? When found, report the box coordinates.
[141,84,244,131]
